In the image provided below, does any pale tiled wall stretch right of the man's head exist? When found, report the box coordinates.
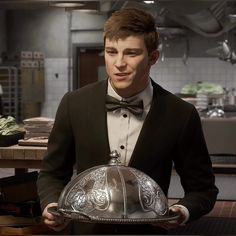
[151,58,236,93]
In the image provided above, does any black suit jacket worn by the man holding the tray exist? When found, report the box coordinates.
[38,81,218,234]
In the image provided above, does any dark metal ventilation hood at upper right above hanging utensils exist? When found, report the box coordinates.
[123,0,236,37]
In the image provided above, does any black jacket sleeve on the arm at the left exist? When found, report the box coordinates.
[37,93,75,209]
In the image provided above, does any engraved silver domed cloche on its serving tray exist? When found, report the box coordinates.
[49,151,178,224]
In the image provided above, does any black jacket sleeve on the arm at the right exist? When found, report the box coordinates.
[174,108,218,221]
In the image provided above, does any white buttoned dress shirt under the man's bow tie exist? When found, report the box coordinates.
[107,81,153,165]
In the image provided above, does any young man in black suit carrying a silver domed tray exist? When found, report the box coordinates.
[38,9,218,234]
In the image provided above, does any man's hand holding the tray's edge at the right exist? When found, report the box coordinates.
[155,206,187,230]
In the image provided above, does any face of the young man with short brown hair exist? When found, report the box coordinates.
[105,36,159,98]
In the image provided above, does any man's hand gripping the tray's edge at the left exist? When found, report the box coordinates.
[42,203,70,232]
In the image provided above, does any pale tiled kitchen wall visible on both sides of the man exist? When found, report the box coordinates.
[41,58,236,118]
